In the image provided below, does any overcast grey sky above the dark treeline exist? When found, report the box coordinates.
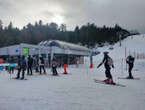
[0,0,145,33]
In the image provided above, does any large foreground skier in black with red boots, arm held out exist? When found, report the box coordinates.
[97,51,115,85]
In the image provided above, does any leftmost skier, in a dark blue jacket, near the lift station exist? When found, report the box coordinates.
[16,56,27,80]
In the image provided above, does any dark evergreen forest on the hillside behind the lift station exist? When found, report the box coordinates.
[0,20,130,47]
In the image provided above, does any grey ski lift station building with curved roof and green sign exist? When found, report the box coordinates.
[0,40,91,64]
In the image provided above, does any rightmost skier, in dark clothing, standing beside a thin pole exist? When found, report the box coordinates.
[126,55,135,79]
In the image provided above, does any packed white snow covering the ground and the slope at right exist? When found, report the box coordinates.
[0,35,145,110]
